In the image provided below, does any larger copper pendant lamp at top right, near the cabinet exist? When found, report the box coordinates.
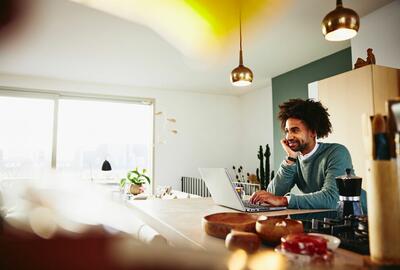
[322,0,360,41]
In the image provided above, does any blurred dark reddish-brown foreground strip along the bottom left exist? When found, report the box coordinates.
[0,219,231,270]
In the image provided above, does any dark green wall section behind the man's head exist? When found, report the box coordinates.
[272,47,352,171]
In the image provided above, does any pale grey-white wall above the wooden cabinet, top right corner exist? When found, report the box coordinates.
[351,0,400,68]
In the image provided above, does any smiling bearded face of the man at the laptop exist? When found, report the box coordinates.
[285,118,316,154]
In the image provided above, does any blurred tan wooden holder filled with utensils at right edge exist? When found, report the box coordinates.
[365,114,400,266]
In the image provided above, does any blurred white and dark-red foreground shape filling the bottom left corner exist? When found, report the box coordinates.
[0,178,226,269]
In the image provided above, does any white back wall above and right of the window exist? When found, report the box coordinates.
[0,74,241,189]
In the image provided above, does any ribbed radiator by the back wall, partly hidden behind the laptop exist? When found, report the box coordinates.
[181,176,260,197]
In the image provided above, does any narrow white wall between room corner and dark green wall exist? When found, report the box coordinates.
[236,86,274,177]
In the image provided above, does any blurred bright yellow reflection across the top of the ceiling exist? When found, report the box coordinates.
[70,0,290,61]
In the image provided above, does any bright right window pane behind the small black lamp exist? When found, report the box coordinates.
[57,99,153,179]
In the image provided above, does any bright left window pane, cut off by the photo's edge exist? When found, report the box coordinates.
[0,96,54,179]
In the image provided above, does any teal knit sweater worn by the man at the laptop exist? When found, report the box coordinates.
[267,143,366,209]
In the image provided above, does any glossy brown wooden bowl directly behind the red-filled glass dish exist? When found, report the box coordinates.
[256,217,304,244]
